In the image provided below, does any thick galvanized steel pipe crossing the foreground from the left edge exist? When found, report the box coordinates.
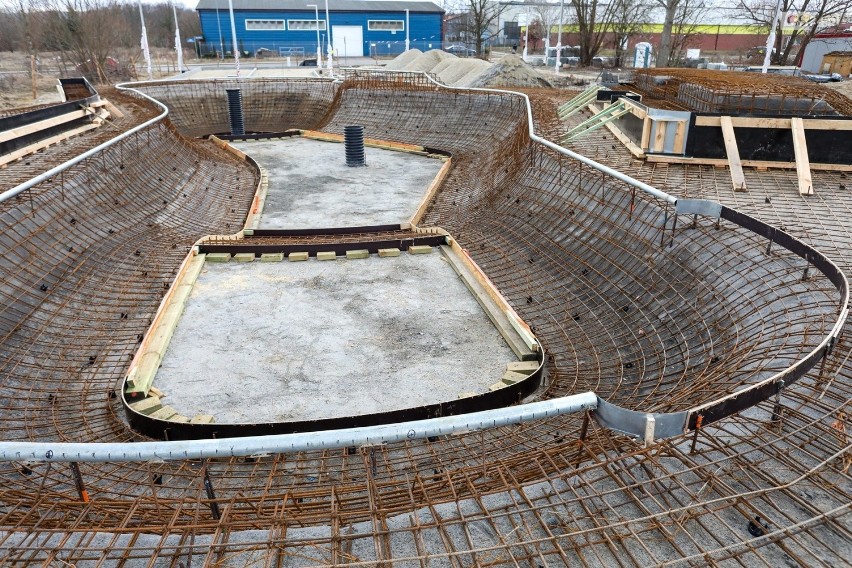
[0,392,598,462]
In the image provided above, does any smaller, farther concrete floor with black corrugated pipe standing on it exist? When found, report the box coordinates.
[232,137,443,229]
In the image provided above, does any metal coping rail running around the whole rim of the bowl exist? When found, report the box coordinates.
[0,74,849,462]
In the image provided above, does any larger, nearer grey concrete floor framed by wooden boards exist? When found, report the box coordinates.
[154,249,516,423]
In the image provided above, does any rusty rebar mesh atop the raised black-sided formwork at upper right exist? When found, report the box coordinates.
[631,69,852,116]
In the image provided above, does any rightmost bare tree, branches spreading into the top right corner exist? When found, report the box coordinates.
[732,0,852,65]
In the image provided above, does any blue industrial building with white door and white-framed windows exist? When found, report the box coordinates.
[196,0,444,58]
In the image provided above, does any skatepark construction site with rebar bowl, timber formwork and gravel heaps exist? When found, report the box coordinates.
[0,54,852,568]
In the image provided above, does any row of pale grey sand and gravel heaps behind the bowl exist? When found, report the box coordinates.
[385,49,552,87]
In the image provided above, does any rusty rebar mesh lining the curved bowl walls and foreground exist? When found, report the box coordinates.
[0,82,852,567]
